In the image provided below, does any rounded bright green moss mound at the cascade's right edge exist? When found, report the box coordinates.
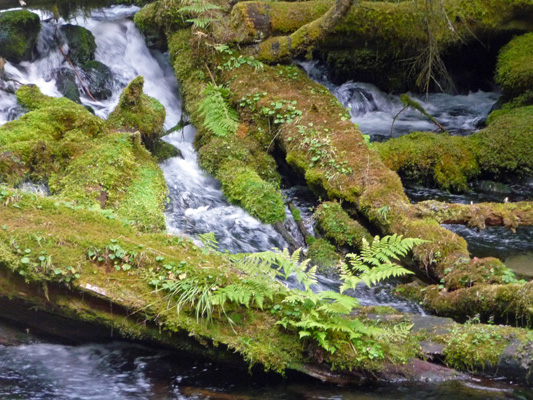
[216,161,285,224]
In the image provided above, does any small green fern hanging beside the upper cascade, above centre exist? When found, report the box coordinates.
[199,83,239,137]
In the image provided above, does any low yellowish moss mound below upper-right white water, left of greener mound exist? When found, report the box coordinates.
[374,132,480,192]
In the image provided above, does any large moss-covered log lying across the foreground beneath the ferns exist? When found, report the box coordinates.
[0,189,531,383]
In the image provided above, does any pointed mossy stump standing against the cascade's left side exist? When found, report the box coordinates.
[107,76,166,150]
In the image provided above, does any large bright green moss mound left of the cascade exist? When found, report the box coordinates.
[0,87,167,230]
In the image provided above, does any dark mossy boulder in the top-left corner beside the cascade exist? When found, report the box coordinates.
[0,10,41,63]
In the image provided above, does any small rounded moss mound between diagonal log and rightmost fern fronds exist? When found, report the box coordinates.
[314,201,372,248]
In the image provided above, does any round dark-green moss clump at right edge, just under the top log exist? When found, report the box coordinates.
[495,33,533,97]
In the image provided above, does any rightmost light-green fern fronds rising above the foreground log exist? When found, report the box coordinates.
[340,235,426,293]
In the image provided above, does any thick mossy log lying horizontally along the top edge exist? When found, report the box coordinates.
[232,0,533,47]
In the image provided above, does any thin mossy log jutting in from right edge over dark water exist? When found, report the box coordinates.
[415,201,533,231]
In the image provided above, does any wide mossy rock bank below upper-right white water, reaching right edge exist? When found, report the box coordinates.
[374,106,533,191]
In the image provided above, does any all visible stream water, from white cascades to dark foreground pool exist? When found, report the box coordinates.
[0,6,533,400]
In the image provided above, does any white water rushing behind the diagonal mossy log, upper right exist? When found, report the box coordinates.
[299,61,499,141]
